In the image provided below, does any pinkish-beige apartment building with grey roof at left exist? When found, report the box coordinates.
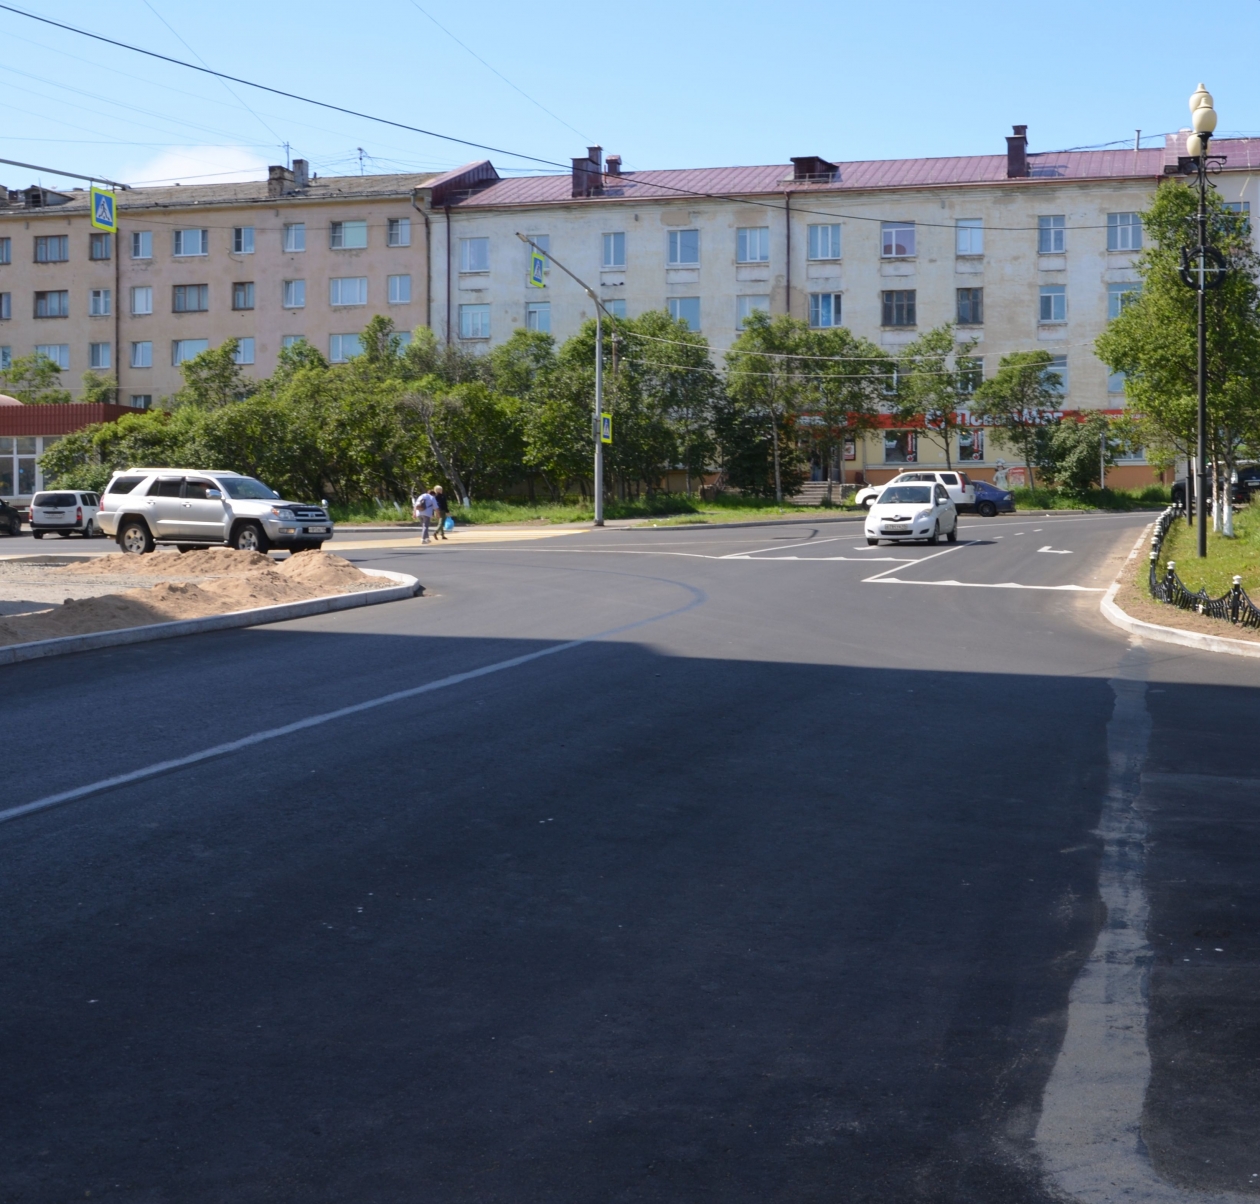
[0,160,432,407]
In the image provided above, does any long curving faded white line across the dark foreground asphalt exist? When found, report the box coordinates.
[0,582,707,824]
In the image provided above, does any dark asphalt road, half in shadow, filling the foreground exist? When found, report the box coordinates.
[0,515,1260,1204]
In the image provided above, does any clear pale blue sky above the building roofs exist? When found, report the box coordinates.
[0,0,1260,188]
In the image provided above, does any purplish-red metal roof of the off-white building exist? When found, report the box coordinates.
[457,139,1260,209]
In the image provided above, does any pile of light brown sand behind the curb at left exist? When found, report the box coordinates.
[0,548,393,645]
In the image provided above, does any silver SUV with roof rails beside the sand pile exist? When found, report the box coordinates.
[96,469,333,553]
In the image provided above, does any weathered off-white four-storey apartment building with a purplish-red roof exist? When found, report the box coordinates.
[422,126,1260,484]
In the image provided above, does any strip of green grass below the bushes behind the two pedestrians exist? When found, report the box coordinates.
[329,494,839,525]
